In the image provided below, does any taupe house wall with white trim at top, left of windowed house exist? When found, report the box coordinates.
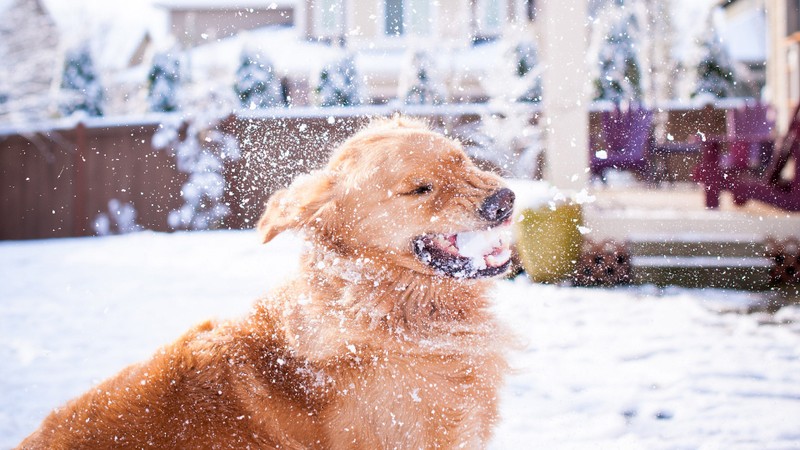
[157,0,295,48]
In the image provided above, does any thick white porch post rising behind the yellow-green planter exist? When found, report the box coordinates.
[537,0,590,191]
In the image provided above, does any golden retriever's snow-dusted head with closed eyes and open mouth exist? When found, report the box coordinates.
[258,118,514,278]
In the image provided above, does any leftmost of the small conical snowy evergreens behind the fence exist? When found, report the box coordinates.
[60,43,103,116]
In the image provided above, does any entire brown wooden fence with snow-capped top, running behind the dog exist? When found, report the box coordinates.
[0,103,736,240]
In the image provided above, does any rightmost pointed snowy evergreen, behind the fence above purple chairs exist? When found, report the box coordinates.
[692,17,736,98]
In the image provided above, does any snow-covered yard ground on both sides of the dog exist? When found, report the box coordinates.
[0,231,800,449]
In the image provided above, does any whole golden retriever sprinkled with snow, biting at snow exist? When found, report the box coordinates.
[20,117,514,449]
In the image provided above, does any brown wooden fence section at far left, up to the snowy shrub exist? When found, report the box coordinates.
[0,119,184,239]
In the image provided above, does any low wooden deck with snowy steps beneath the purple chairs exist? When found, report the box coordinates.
[583,184,800,297]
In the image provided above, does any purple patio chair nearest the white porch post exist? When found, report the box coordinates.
[589,105,653,179]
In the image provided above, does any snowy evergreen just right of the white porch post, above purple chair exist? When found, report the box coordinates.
[594,1,642,103]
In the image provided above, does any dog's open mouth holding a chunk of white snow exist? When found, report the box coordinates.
[414,223,511,278]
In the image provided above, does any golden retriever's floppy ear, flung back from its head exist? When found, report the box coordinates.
[258,171,334,243]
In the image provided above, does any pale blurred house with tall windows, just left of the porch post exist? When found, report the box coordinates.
[296,0,536,103]
